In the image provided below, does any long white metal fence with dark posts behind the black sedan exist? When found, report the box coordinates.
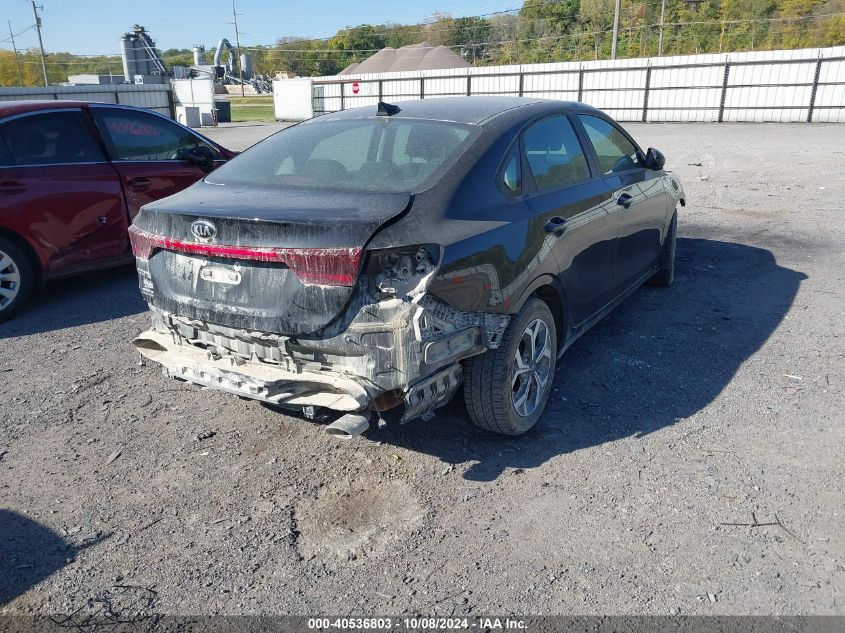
[270,46,845,122]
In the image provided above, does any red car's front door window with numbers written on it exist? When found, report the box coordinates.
[92,108,219,160]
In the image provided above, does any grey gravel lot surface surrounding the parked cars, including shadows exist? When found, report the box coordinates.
[0,124,845,615]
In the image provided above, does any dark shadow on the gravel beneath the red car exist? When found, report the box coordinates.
[0,266,147,339]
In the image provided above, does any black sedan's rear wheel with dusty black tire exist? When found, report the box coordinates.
[464,298,557,435]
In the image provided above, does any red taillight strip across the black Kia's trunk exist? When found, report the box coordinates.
[129,226,361,286]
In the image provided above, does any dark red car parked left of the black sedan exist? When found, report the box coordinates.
[0,101,236,321]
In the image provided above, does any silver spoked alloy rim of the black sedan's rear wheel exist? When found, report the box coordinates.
[511,319,554,417]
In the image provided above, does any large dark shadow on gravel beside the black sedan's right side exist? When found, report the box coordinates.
[372,238,806,481]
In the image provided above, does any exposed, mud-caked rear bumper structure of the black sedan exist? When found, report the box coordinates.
[133,295,508,422]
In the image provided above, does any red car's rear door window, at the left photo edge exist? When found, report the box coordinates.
[0,111,105,166]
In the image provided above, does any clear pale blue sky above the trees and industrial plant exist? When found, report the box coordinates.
[0,0,522,55]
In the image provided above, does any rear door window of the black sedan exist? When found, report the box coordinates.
[524,116,590,192]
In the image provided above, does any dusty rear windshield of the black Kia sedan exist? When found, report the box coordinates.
[206,117,476,193]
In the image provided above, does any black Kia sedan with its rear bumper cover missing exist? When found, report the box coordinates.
[130,97,684,437]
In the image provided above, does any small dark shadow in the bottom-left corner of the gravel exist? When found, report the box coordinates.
[0,509,75,606]
